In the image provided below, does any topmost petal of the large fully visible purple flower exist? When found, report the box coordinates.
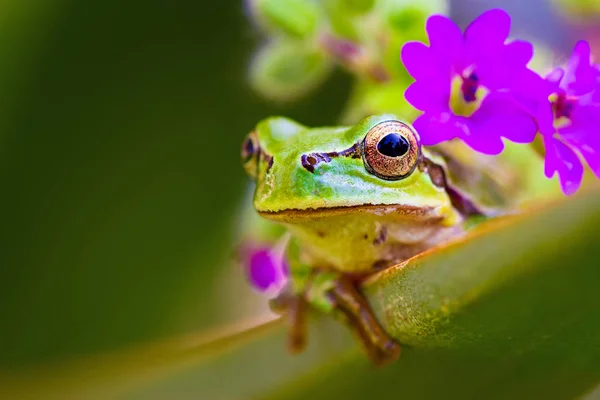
[465,9,510,49]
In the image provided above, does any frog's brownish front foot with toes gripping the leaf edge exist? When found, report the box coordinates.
[270,271,400,365]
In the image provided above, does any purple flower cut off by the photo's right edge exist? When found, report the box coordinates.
[536,41,600,195]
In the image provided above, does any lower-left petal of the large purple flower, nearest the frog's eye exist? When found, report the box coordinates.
[413,112,463,146]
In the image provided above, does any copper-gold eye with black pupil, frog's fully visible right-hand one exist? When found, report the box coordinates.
[362,121,421,180]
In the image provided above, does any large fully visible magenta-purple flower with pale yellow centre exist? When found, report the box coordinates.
[401,9,539,154]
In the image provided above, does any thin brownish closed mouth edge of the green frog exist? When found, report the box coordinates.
[259,204,444,222]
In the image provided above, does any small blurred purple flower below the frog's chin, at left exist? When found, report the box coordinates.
[245,247,288,292]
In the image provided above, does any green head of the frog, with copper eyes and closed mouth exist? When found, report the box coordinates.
[242,114,462,225]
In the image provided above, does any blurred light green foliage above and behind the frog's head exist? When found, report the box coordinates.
[244,0,446,105]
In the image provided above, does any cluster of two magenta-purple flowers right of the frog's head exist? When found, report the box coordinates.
[401,9,600,195]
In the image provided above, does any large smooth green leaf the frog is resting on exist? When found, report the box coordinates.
[0,187,600,399]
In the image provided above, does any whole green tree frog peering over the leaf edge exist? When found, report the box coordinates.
[241,114,512,365]
